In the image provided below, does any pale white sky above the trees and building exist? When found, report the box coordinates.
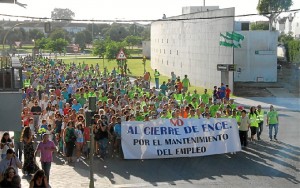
[0,0,300,21]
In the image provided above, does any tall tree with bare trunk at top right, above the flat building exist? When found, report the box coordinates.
[256,0,293,31]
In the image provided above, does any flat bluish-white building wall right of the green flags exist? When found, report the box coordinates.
[234,31,278,82]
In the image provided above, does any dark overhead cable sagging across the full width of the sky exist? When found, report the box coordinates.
[0,9,300,23]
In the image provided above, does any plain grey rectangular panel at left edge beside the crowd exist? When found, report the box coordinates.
[0,92,22,131]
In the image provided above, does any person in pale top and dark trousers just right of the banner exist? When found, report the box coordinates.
[238,110,251,147]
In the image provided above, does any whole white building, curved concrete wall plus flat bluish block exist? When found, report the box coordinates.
[151,8,278,89]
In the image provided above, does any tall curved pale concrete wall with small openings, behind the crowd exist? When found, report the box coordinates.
[151,8,235,88]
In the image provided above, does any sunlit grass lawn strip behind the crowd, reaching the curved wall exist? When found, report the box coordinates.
[58,56,212,94]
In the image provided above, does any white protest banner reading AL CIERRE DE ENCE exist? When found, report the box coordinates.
[122,118,241,159]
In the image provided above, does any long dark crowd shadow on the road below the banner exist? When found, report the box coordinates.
[55,141,300,186]
